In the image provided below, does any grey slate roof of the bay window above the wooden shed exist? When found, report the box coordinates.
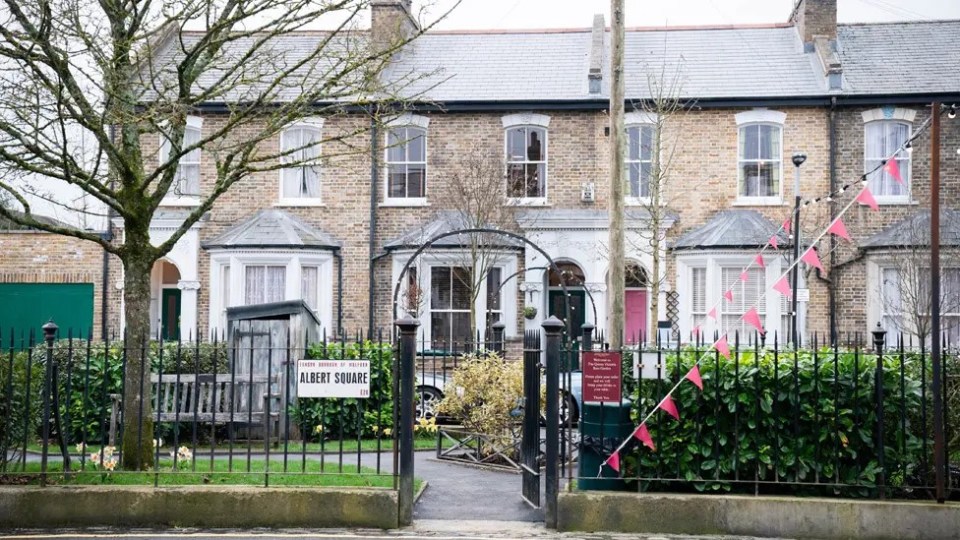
[203,209,340,250]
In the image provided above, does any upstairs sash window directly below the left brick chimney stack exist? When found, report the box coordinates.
[387,126,427,199]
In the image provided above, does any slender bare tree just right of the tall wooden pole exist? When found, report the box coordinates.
[627,63,693,335]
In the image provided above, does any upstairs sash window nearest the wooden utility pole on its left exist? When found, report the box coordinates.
[507,126,547,199]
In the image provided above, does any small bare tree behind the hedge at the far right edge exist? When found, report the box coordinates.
[879,210,960,342]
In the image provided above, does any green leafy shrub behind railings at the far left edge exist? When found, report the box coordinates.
[0,352,44,471]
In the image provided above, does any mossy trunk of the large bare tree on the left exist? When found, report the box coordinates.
[121,223,154,470]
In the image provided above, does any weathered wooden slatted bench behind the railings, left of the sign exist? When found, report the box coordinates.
[150,373,281,425]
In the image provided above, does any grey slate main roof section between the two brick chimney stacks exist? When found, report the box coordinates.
[392,25,826,101]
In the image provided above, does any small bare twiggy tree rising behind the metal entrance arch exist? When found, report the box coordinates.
[437,144,517,344]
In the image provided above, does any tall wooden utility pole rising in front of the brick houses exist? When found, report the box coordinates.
[607,0,628,350]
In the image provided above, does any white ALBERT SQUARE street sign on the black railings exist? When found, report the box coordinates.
[297,360,370,398]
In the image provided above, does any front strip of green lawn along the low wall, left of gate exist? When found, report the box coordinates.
[6,458,423,489]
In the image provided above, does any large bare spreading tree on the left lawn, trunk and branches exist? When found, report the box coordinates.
[0,0,454,469]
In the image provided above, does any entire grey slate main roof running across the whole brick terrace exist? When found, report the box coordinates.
[144,20,960,103]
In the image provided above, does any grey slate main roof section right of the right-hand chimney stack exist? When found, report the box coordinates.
[837,20,960,95]
